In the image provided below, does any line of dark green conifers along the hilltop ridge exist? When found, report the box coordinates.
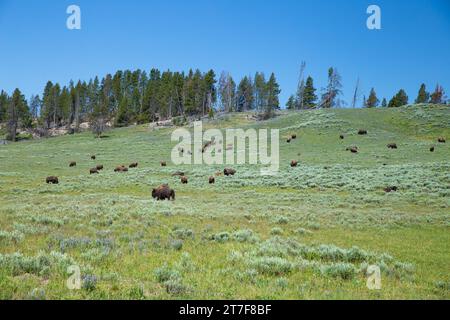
[0,62,446,141]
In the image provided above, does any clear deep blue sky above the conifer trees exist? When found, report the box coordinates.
[0,0,450,105]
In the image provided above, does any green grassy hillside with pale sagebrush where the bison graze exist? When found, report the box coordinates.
[0,106,450,299]
